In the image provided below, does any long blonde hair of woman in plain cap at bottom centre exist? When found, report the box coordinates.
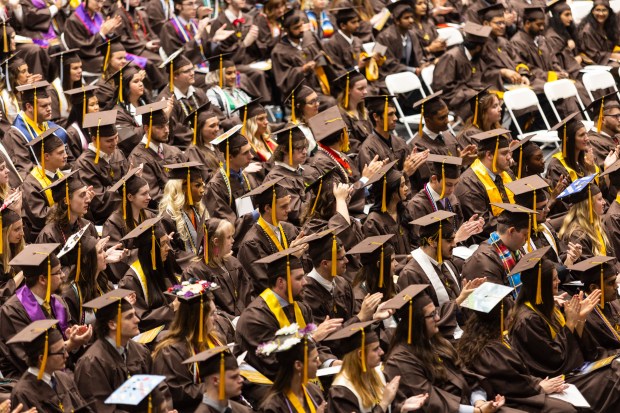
[336,351,385,409]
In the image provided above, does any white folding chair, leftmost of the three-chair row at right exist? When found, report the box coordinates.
[504,87,560,160]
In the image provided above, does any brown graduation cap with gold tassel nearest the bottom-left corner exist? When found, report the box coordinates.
[7,319,63,380]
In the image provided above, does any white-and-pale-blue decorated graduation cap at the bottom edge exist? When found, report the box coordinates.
[104,374,166,413]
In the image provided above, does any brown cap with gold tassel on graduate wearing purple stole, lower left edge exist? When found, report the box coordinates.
[9,244,60,305]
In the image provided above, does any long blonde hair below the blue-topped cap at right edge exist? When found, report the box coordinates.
[558,199,609,255]
